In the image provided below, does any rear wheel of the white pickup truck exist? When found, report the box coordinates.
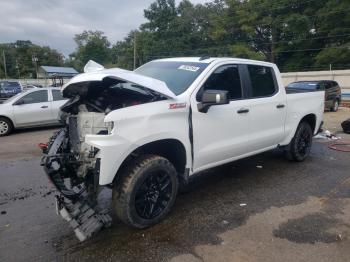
[285,122,313,162]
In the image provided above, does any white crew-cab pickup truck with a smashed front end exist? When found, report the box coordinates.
[42,57,324,240]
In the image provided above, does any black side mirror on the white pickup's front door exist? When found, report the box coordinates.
[198,90,230,113]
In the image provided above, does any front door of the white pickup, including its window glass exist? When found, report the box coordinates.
[191,65,251,172]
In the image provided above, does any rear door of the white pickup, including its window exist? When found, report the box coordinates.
[246,65,287,151]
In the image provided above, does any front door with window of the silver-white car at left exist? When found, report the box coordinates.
[13,90,52,126]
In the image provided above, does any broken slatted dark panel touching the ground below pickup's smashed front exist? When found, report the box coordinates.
[55,195,112,241]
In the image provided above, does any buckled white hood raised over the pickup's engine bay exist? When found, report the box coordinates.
[62,68,176,98]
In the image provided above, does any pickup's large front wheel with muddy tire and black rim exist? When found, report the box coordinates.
[113,155,179,228]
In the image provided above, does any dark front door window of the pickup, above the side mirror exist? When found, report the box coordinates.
[201,65,242,100]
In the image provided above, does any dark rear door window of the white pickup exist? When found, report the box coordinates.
[248,65,277,98]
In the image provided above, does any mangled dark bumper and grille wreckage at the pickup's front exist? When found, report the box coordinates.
[42,125,112,241]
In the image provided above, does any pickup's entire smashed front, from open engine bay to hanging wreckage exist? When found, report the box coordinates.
[41,71,170,241]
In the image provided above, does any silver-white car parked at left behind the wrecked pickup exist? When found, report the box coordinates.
[0,88,67,136]
